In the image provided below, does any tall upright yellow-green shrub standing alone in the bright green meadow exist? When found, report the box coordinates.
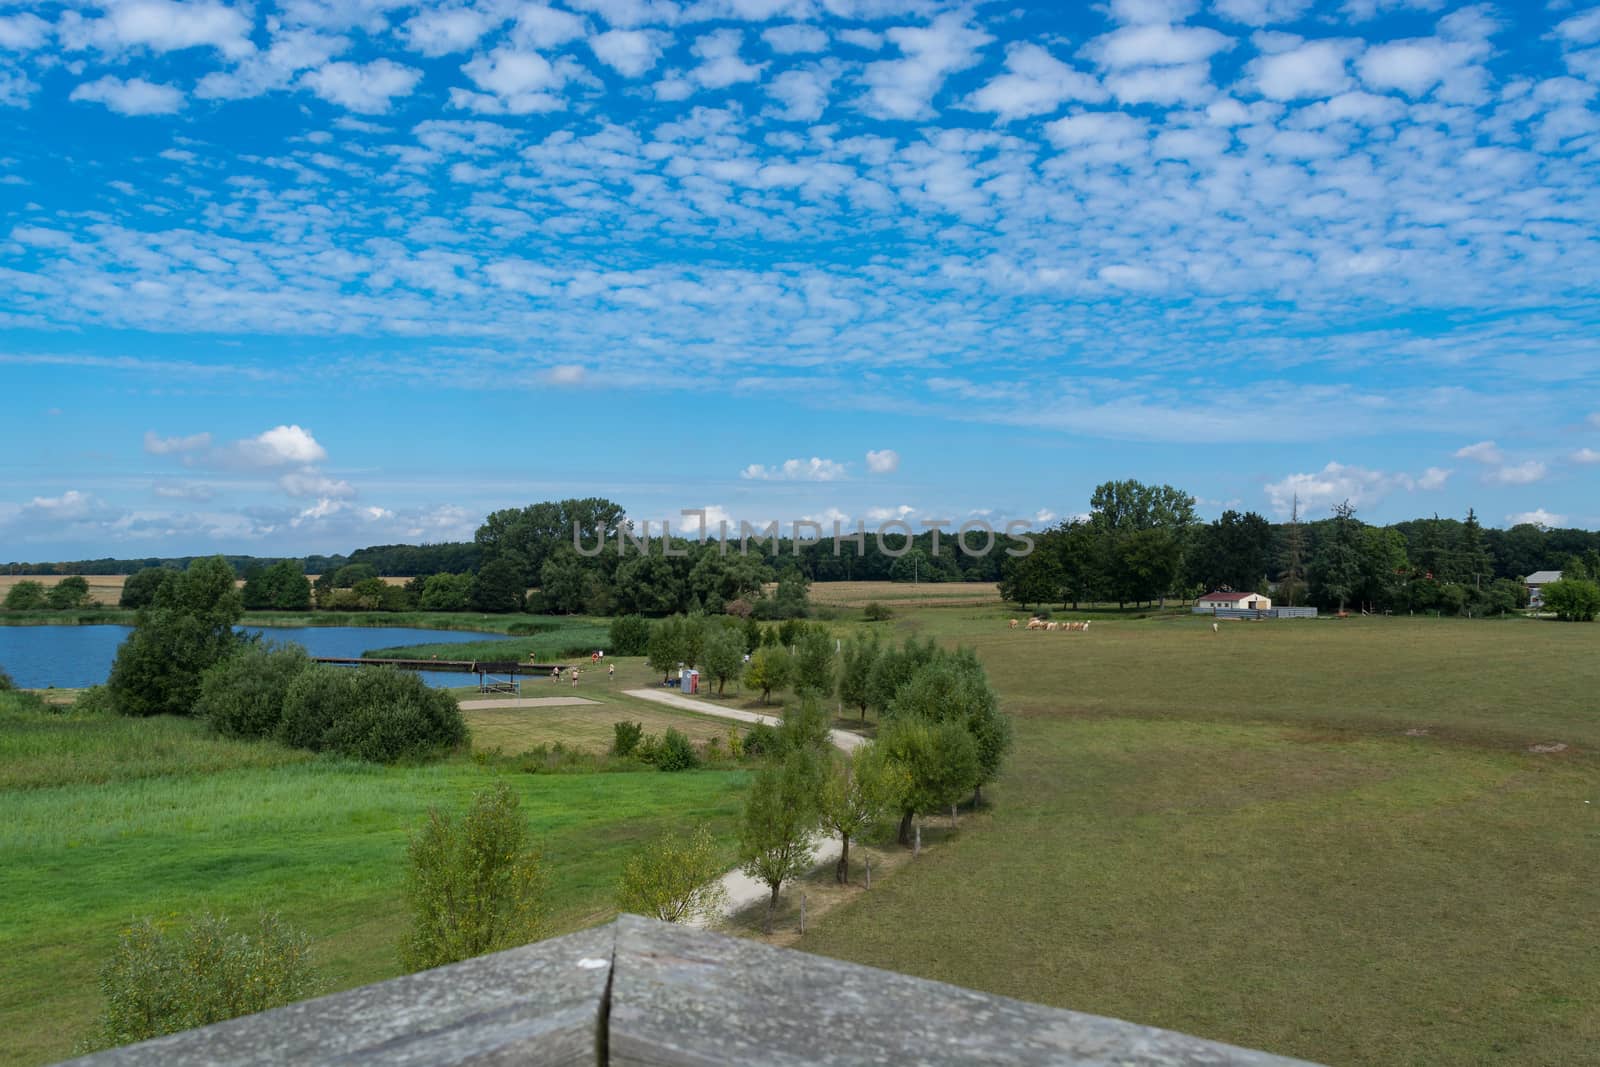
[400,782,546,971]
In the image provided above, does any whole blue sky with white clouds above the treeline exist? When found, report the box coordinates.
[0,0,1600,558]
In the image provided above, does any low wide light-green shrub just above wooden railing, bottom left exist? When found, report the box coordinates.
[94,915,322,1048]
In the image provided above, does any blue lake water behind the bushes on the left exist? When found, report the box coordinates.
[0,625,498,689]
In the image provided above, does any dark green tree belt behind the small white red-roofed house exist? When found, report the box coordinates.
[1000,482,1580,614]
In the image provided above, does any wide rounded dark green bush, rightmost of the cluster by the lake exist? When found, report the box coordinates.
[277,665,467,763]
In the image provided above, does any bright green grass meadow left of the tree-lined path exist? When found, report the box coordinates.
[0,693,746,1064]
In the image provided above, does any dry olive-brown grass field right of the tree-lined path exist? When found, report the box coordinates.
[798,609,1600,1065]
